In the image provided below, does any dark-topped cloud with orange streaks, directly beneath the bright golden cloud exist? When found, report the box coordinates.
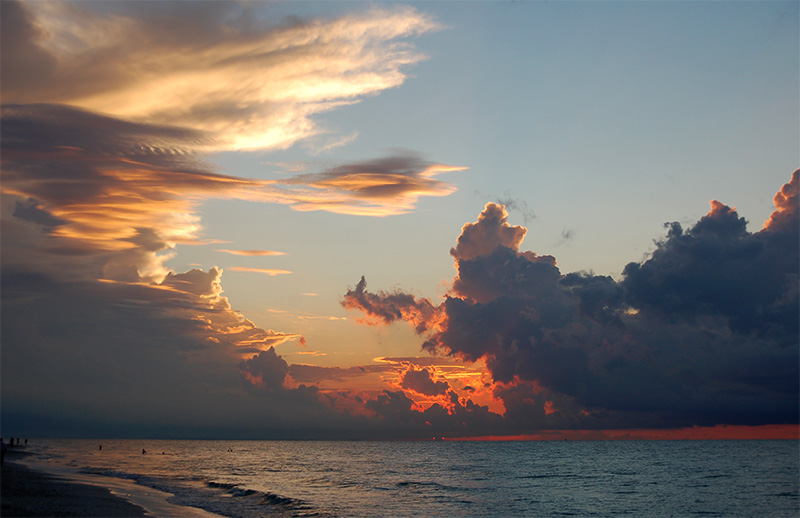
[1,105,238,282]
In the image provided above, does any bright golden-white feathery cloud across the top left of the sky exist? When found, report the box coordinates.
[2,2,439,150]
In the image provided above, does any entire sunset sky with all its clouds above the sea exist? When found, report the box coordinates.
[0,0,800,439]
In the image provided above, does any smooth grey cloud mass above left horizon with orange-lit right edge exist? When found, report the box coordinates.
[0,268,306,436]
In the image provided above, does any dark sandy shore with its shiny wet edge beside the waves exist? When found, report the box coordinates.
[0,450,224,518]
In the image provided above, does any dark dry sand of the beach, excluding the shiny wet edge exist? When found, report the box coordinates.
[0,451,148,518]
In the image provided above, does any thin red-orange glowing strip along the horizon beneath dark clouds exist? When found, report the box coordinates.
[433,424,800,441]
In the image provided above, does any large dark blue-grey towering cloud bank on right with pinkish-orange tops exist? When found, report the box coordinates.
[345,172,800,430]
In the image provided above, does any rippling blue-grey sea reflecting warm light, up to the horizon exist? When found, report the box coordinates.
[21,440,800,518]
